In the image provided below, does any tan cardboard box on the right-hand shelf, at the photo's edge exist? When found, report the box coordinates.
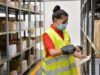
[94,20,100,50]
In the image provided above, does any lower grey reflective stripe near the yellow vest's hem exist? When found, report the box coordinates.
[42,63,76,75]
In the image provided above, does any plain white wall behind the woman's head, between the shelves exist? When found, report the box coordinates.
[45,1,80,45]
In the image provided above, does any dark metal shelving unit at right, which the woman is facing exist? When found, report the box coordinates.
[80,0,100,75]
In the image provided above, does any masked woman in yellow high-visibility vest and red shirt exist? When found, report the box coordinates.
[42,5,83,75]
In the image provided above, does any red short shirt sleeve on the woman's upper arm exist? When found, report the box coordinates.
[43,33,55,54]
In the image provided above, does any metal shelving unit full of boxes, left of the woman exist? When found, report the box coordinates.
[0,0,45,75]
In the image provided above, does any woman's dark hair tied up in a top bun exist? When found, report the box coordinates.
[52,5,68,21]
